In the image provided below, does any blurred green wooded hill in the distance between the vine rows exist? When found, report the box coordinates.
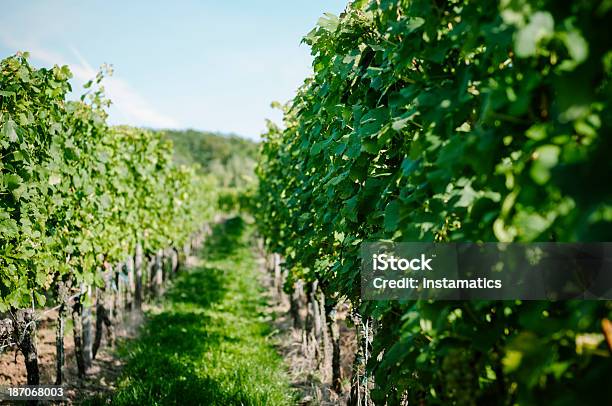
[164,130,258,187]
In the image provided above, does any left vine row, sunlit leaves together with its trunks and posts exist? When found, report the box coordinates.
[0,55,215,390]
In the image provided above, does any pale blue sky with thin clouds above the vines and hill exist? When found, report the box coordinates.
[0,0,347,139]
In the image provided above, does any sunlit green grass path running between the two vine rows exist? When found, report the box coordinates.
[98,218,295,405]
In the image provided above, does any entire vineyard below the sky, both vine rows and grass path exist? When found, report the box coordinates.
[0,0,612,406]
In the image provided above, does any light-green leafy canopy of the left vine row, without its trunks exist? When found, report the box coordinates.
[0,54,215,312]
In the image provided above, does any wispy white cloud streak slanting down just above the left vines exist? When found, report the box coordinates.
[0,34,179,128]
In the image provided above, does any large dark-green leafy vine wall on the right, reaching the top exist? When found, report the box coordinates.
[256,0,612,405]
